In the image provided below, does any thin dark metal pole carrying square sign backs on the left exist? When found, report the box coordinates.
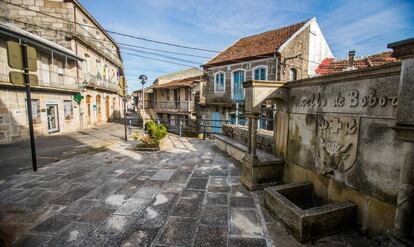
[20,40,37,171]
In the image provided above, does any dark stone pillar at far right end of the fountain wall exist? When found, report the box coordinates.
[388,38,414,246]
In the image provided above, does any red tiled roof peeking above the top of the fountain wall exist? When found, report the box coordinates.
[315,51,398,75]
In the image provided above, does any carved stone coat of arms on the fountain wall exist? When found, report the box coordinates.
[316,115,359,173]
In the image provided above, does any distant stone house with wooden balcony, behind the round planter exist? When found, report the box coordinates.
[135,68,204,132]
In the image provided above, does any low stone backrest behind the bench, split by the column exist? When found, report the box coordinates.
[223,124,273,152]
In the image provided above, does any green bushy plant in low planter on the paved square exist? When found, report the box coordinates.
[134,121,168,151]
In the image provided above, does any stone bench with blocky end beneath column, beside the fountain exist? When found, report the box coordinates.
[213,134,285,190]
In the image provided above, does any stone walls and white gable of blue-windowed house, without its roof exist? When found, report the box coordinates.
[201,19,333,134]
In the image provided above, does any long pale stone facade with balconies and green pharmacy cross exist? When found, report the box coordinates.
[0,0,126,143]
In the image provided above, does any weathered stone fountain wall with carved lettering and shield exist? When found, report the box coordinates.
[276,63,407,234]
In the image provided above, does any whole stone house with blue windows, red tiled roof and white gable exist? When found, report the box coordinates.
[202,18,333,131]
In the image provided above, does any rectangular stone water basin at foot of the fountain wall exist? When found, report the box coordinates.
[265,182,356,242]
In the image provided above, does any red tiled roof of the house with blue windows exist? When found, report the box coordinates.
[204,21,307,66]
